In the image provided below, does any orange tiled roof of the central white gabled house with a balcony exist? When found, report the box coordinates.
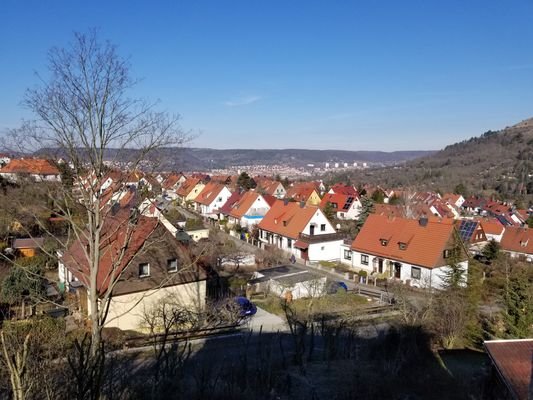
[259,200,321,239]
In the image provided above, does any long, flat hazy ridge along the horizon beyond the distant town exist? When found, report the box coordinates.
[32,147,433,171]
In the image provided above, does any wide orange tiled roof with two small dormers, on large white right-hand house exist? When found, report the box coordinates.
[352,214,460,268]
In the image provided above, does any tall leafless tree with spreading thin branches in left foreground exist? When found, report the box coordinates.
[8,31,189,356]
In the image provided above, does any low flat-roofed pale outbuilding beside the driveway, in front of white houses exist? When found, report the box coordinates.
[246,265,327,300]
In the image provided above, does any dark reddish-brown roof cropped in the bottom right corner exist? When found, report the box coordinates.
[484,339,533,400]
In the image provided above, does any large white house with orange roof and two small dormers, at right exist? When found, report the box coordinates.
[350,214,468,289]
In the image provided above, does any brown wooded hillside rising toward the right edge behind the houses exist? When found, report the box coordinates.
[330,119,533,199]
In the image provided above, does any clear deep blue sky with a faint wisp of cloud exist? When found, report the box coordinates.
[0,0,533,151]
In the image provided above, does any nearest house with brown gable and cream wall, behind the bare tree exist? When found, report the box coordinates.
[58,210,206,330]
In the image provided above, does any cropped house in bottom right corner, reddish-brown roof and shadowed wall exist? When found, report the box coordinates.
[483,339,533,400]
